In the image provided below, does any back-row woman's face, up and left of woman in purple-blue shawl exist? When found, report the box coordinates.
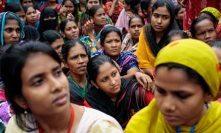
[93,8,106,25]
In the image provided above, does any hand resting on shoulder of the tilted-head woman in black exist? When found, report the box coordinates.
[135,72,153,90]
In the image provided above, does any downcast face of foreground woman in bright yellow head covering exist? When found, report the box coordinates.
[154,67,209,126]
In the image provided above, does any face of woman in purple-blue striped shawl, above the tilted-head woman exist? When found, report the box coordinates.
[102,31,121,57]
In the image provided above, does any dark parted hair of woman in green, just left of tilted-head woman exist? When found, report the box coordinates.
[61,39,91,62]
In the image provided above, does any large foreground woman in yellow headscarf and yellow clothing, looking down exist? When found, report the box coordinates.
[125,39,221,133]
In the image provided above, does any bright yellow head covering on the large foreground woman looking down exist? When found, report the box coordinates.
[155,39,220,97]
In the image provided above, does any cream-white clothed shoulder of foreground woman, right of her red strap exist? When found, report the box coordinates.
[77,107,123,133]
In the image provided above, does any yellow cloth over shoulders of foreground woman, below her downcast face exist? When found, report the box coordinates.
[125,100,221,133]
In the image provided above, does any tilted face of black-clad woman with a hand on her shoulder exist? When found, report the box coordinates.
[95,62,121,98]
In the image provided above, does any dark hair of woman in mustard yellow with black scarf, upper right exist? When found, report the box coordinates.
[152,0,175,30]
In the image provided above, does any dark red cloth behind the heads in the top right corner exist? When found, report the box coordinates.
[183,0,221,30]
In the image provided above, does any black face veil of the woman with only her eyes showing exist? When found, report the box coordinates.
[38,7,58,34]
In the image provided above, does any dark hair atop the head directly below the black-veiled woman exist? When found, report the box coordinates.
[41,30,62,45]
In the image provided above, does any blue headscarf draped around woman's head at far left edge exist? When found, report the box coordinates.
[0,12,25,46]
